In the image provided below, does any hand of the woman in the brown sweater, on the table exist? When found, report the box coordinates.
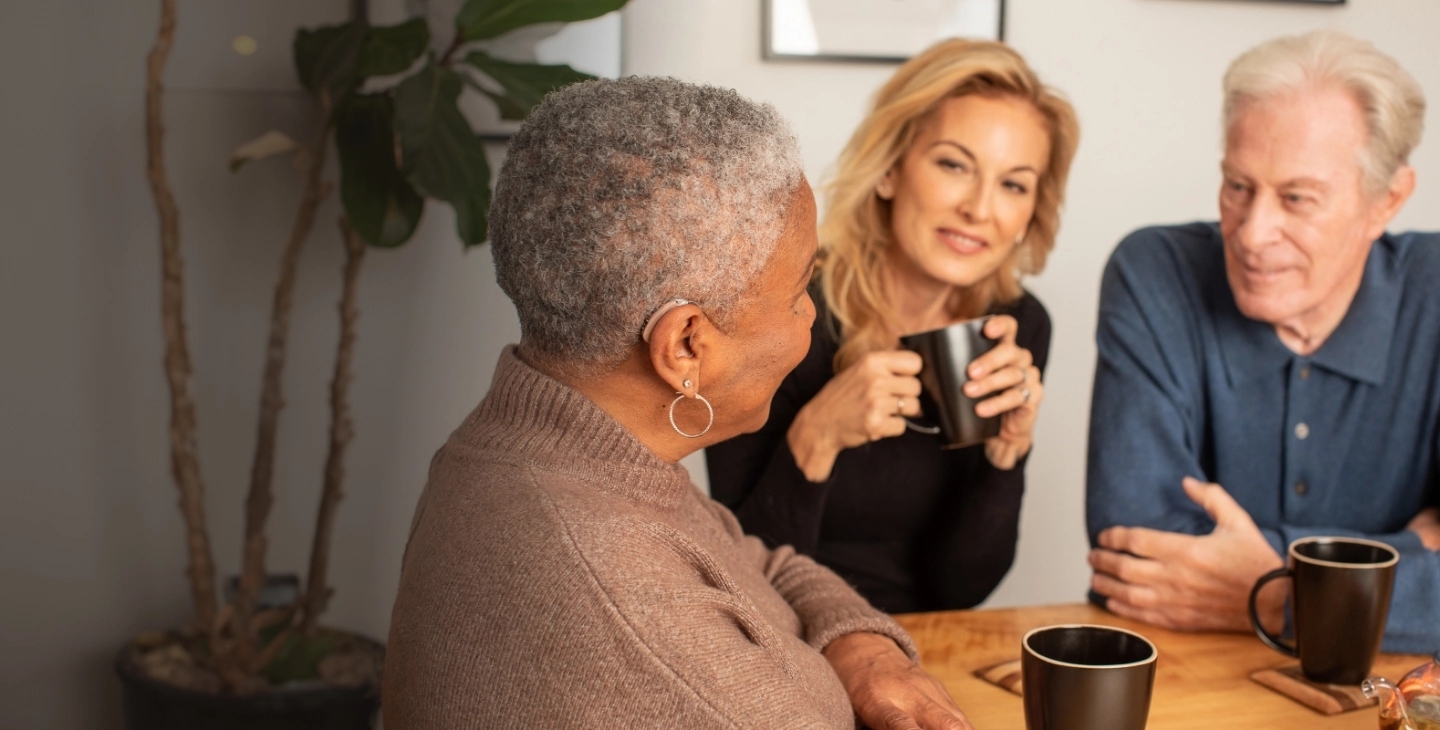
[825,634,973,730]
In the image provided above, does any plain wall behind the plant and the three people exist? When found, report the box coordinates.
[0,0,1440,730]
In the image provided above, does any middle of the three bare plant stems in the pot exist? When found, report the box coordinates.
[230,108,330,665]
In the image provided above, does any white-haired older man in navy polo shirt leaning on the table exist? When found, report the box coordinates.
[1087,32,1440,652]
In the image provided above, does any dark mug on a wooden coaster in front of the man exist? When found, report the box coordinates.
[1250,537,1400,684]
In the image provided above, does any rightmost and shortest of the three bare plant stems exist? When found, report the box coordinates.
[301,216,366,635]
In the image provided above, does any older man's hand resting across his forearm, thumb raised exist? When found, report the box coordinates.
[1090,477,1289,634]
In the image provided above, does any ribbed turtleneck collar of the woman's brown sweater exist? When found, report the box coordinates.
[451,346,694,507]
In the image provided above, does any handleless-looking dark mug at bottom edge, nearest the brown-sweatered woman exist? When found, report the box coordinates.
[1020,625,1159,730]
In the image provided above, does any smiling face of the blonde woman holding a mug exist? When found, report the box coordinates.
[876,94,1050,292]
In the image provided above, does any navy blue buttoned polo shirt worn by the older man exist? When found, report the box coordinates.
[1086,223,1440,652]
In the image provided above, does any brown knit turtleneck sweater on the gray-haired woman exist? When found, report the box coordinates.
[383,348,914,730]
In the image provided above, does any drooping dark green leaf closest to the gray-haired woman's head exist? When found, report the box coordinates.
[395,63,490,246]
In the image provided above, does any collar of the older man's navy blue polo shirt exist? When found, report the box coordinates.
[1211,232,1401,386]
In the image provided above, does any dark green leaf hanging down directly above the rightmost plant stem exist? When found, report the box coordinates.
[336,94,425,246]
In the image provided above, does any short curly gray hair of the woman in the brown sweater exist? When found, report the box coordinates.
[490,76,804,373]
